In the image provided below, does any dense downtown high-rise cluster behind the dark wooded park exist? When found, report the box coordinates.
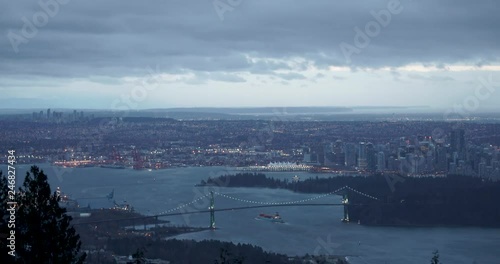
[304,129,500,177]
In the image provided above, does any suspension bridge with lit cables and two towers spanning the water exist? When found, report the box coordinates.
[72,186,379,229]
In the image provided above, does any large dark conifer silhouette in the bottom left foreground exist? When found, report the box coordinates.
[12,166,86,263]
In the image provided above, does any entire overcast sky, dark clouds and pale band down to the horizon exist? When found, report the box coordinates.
[0,0,500,110]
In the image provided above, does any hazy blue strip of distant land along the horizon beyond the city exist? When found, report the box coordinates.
[0,106,500,122]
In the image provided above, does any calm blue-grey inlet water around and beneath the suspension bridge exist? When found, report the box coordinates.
[4,165,500,264]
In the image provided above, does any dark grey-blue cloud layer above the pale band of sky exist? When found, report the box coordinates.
[0,0,500,78]
